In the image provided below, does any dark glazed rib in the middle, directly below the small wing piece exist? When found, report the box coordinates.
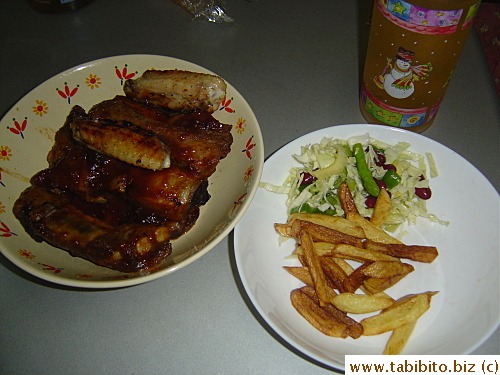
[31,114,209,221]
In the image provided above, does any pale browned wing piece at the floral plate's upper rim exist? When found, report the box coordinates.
[123,70,227,113]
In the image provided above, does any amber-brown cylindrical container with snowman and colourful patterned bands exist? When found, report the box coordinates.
[360,0,481,132]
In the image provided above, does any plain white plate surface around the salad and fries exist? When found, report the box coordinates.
[234,124,500,370]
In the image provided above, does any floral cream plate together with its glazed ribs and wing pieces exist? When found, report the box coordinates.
[0,55,264,288]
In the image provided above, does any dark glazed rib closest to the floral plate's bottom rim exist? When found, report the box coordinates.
[14,186,172,272]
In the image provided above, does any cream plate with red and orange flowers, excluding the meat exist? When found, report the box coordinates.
[0,55,264,288]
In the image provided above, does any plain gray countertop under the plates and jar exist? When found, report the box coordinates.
[0,0,500,375]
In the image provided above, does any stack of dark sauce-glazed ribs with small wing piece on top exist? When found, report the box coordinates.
[13,73,233,272]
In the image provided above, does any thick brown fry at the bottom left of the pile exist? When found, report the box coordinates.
[290,288,349,338]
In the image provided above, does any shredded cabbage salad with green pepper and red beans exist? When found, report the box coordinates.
[260,134,448,232]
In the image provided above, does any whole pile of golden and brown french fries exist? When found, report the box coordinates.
[275,183,438,355]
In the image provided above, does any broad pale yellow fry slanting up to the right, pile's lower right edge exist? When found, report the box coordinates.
[361,292,436,336]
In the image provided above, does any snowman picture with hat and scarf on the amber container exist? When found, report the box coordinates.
[373,47,432,99]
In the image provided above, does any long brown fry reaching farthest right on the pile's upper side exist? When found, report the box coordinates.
[364,240,438,263]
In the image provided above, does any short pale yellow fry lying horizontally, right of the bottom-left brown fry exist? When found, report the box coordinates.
[332,293,394,314]
